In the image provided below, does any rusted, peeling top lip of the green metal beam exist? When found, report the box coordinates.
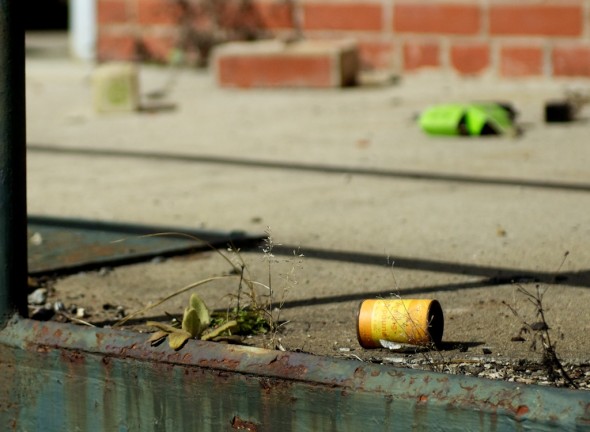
[0,315,590,430]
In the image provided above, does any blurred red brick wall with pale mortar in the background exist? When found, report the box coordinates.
[98,0,590,79]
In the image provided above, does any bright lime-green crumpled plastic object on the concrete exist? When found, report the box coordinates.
[419,103,514,136]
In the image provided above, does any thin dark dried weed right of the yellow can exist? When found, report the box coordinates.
[502,251,579,389]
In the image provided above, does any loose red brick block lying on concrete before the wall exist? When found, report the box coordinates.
[213,40,360,88]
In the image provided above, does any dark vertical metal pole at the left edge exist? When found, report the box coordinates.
[0,0,27,328]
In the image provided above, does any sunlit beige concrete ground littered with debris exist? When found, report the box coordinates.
[27,35,590,361]
